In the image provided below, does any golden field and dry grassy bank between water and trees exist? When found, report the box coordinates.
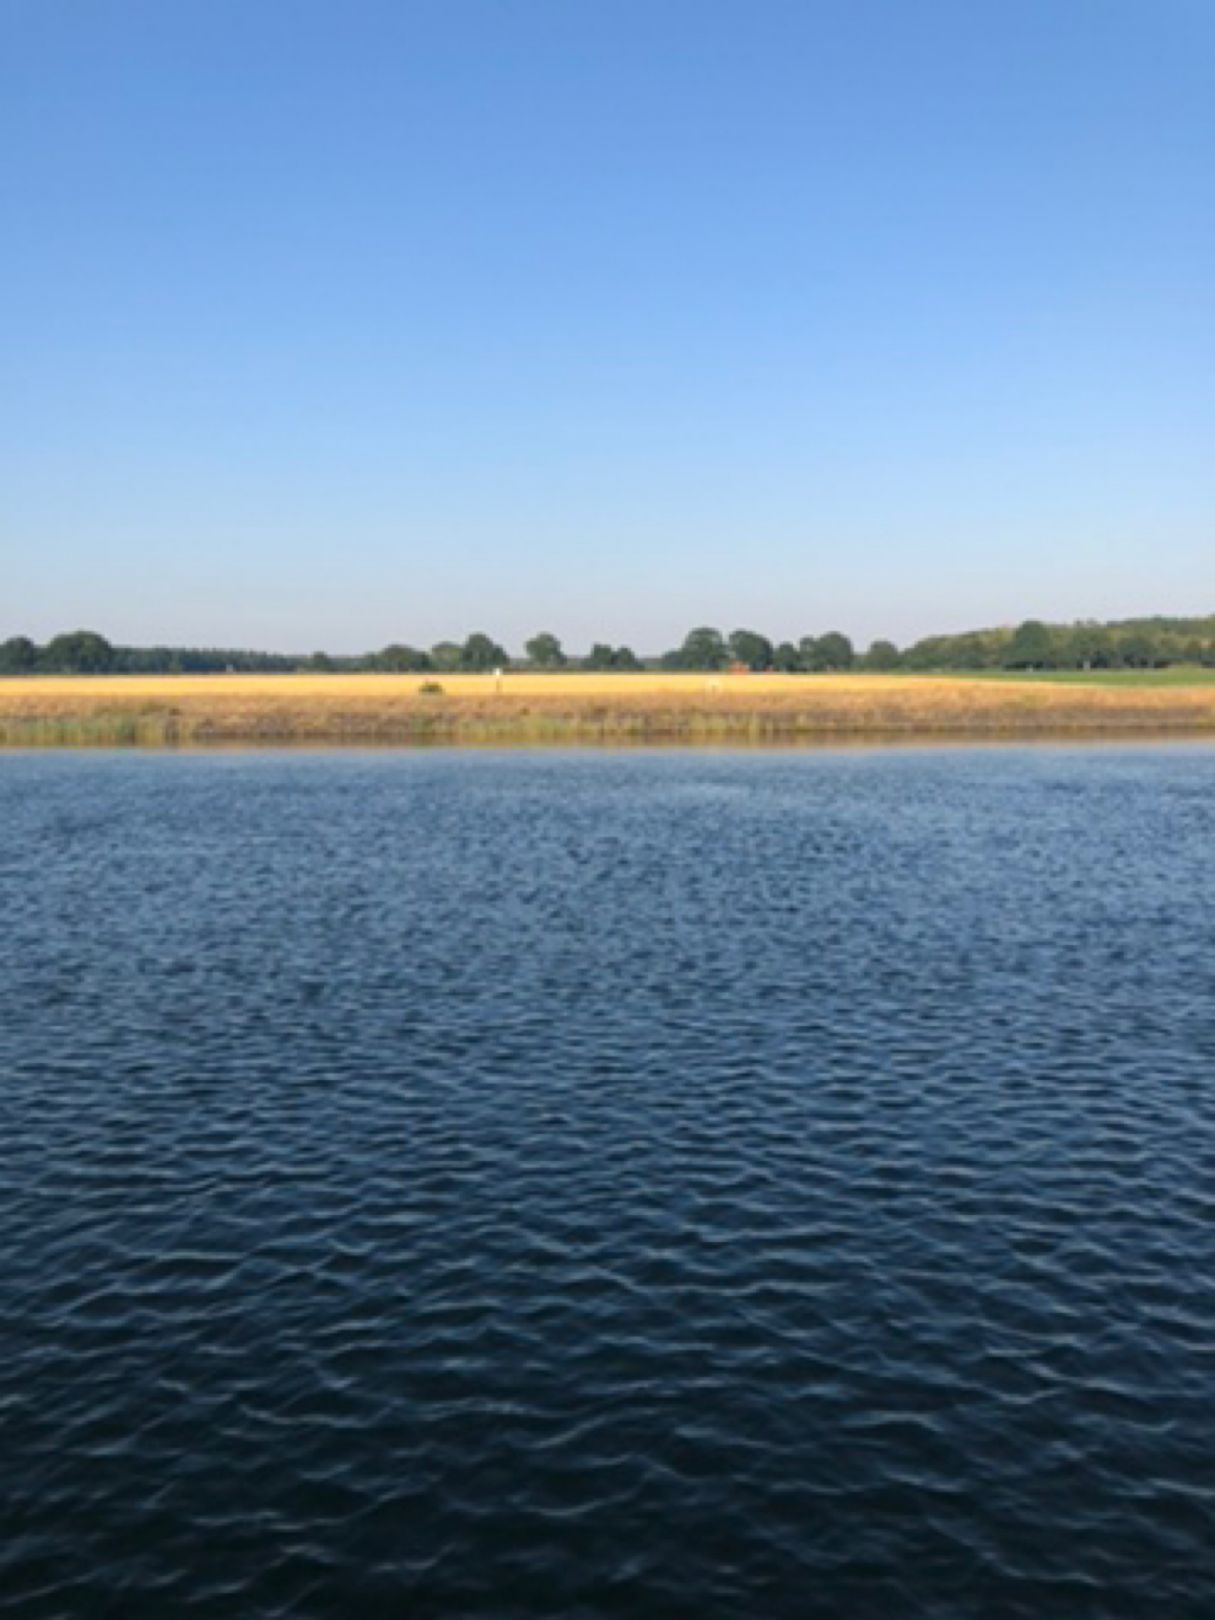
[0,672,1215,745]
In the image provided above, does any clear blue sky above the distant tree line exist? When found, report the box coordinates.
[0,0,1215,651]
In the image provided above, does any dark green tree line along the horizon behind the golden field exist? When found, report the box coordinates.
[0,616,1215,676]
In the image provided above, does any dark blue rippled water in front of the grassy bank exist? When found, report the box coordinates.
[0,747,1215,1620]
